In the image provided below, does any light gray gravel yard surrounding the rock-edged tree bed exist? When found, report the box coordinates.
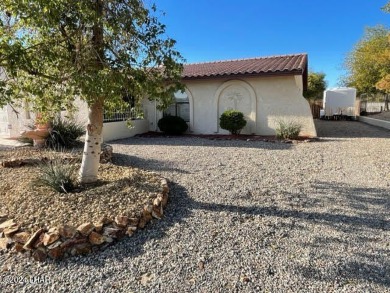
[0,121,390,293]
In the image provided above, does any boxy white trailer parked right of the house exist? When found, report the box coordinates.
[322,87,360,119]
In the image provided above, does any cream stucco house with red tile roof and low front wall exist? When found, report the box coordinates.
[0,54,317,141]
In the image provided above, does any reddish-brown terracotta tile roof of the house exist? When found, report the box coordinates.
[182,54,307,79]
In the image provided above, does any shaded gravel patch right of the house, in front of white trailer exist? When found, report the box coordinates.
[314,119,390,138]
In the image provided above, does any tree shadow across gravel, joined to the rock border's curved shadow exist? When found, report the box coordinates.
[44,182,390,287]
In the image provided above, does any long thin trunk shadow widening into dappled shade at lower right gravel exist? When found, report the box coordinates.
[184,182,390,288]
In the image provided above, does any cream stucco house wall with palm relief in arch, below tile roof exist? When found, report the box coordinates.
[144,76,317,137]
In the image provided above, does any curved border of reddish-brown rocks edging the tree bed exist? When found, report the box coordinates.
[0,178,169,261]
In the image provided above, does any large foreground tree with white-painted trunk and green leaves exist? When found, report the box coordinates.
[0,0,182,182]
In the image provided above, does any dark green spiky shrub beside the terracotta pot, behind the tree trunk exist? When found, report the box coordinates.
[46,118,85,150]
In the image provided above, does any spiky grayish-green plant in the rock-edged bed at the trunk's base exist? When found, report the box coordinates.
[34,159,77,193]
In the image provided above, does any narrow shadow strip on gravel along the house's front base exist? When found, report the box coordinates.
[110,136,293,150]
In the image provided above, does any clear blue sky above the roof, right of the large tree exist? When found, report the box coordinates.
[154,0,390,87]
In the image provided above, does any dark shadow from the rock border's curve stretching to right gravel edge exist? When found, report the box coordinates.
[50,178,390,289]
